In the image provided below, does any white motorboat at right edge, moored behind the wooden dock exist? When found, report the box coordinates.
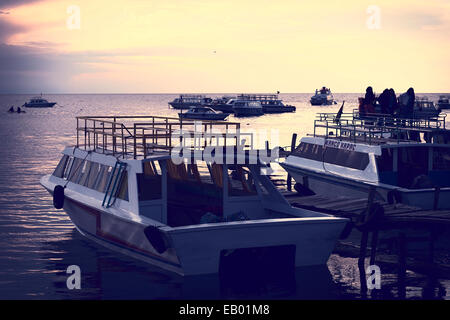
[280,113,450,209]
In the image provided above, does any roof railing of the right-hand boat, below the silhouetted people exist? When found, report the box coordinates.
[313,112,450,145]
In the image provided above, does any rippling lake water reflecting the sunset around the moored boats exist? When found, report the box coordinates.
[0,94,450,299]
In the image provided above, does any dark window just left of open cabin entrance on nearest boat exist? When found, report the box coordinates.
[136,162,162,201]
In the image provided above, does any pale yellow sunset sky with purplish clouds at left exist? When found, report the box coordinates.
[0,0,450,93]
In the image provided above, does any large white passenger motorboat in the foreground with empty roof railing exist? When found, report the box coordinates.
[40,116,348,276]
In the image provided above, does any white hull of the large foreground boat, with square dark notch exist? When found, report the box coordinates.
[41,177,347,275]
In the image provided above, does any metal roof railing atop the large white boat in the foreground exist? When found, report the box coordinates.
[76,116,254,159]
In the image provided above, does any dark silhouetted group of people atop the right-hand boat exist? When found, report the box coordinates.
[359,87,416,118]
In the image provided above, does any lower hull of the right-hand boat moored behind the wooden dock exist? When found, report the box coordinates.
[281,164,450,209]
